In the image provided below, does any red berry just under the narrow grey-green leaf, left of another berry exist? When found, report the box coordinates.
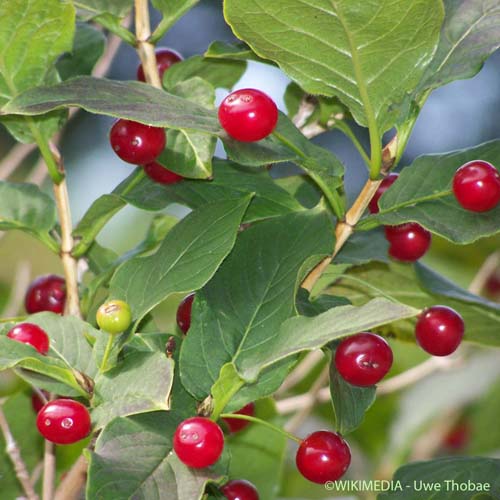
[335,332,392,387]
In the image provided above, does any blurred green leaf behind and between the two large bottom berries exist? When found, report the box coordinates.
[226,400,287,500]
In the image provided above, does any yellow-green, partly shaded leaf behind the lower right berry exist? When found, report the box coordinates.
[335,263,500,346]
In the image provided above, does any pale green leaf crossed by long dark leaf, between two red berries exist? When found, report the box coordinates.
[156,77,216,179]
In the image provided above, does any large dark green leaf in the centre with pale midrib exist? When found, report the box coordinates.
[180,210,333,400]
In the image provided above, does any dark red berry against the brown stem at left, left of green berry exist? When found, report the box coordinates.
[24,274,66,314]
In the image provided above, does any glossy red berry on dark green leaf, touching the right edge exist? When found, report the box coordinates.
[453,160,500,212]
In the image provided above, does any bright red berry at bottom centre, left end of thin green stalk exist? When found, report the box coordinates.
[174,417,224,469]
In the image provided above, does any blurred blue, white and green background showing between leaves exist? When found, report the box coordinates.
[0,0,500,500]
